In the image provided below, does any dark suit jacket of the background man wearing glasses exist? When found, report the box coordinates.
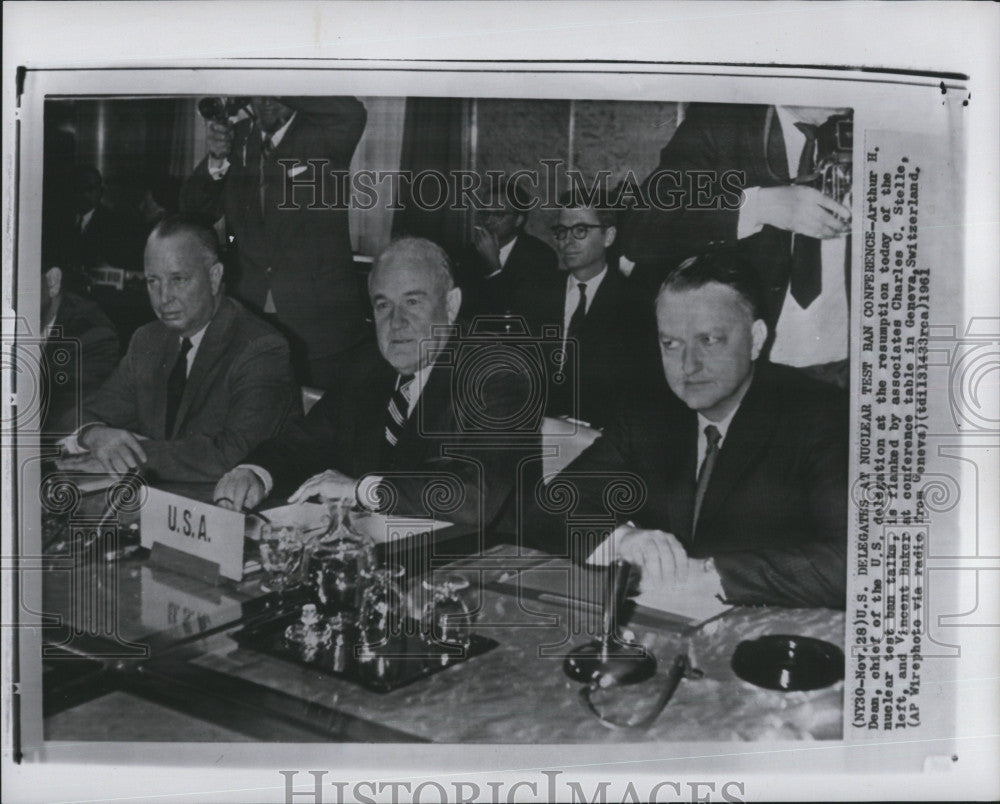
[522,268,663,427]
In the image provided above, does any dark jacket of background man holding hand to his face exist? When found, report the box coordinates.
[458,232,559,320]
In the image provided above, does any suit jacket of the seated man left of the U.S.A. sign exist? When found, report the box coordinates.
[84,297,301,482]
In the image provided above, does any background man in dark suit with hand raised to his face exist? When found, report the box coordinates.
[458,179,557,321]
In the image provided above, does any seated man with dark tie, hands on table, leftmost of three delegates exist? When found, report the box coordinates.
[57,218,300,482]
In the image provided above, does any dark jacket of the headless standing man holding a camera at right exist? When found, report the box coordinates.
[620,103,844,337]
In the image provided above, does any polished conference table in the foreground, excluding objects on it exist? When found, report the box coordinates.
[42,486,844,744]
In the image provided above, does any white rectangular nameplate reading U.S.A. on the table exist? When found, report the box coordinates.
[139,488,245,581]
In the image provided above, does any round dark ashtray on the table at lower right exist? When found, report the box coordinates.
[732,634,844,692]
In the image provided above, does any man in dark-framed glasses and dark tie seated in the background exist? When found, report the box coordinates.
[522,194,659,428]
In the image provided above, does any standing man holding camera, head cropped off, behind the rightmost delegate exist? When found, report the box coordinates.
[622,104,852,387]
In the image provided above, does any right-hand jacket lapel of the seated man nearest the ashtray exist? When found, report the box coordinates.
[698,366,781,536]
